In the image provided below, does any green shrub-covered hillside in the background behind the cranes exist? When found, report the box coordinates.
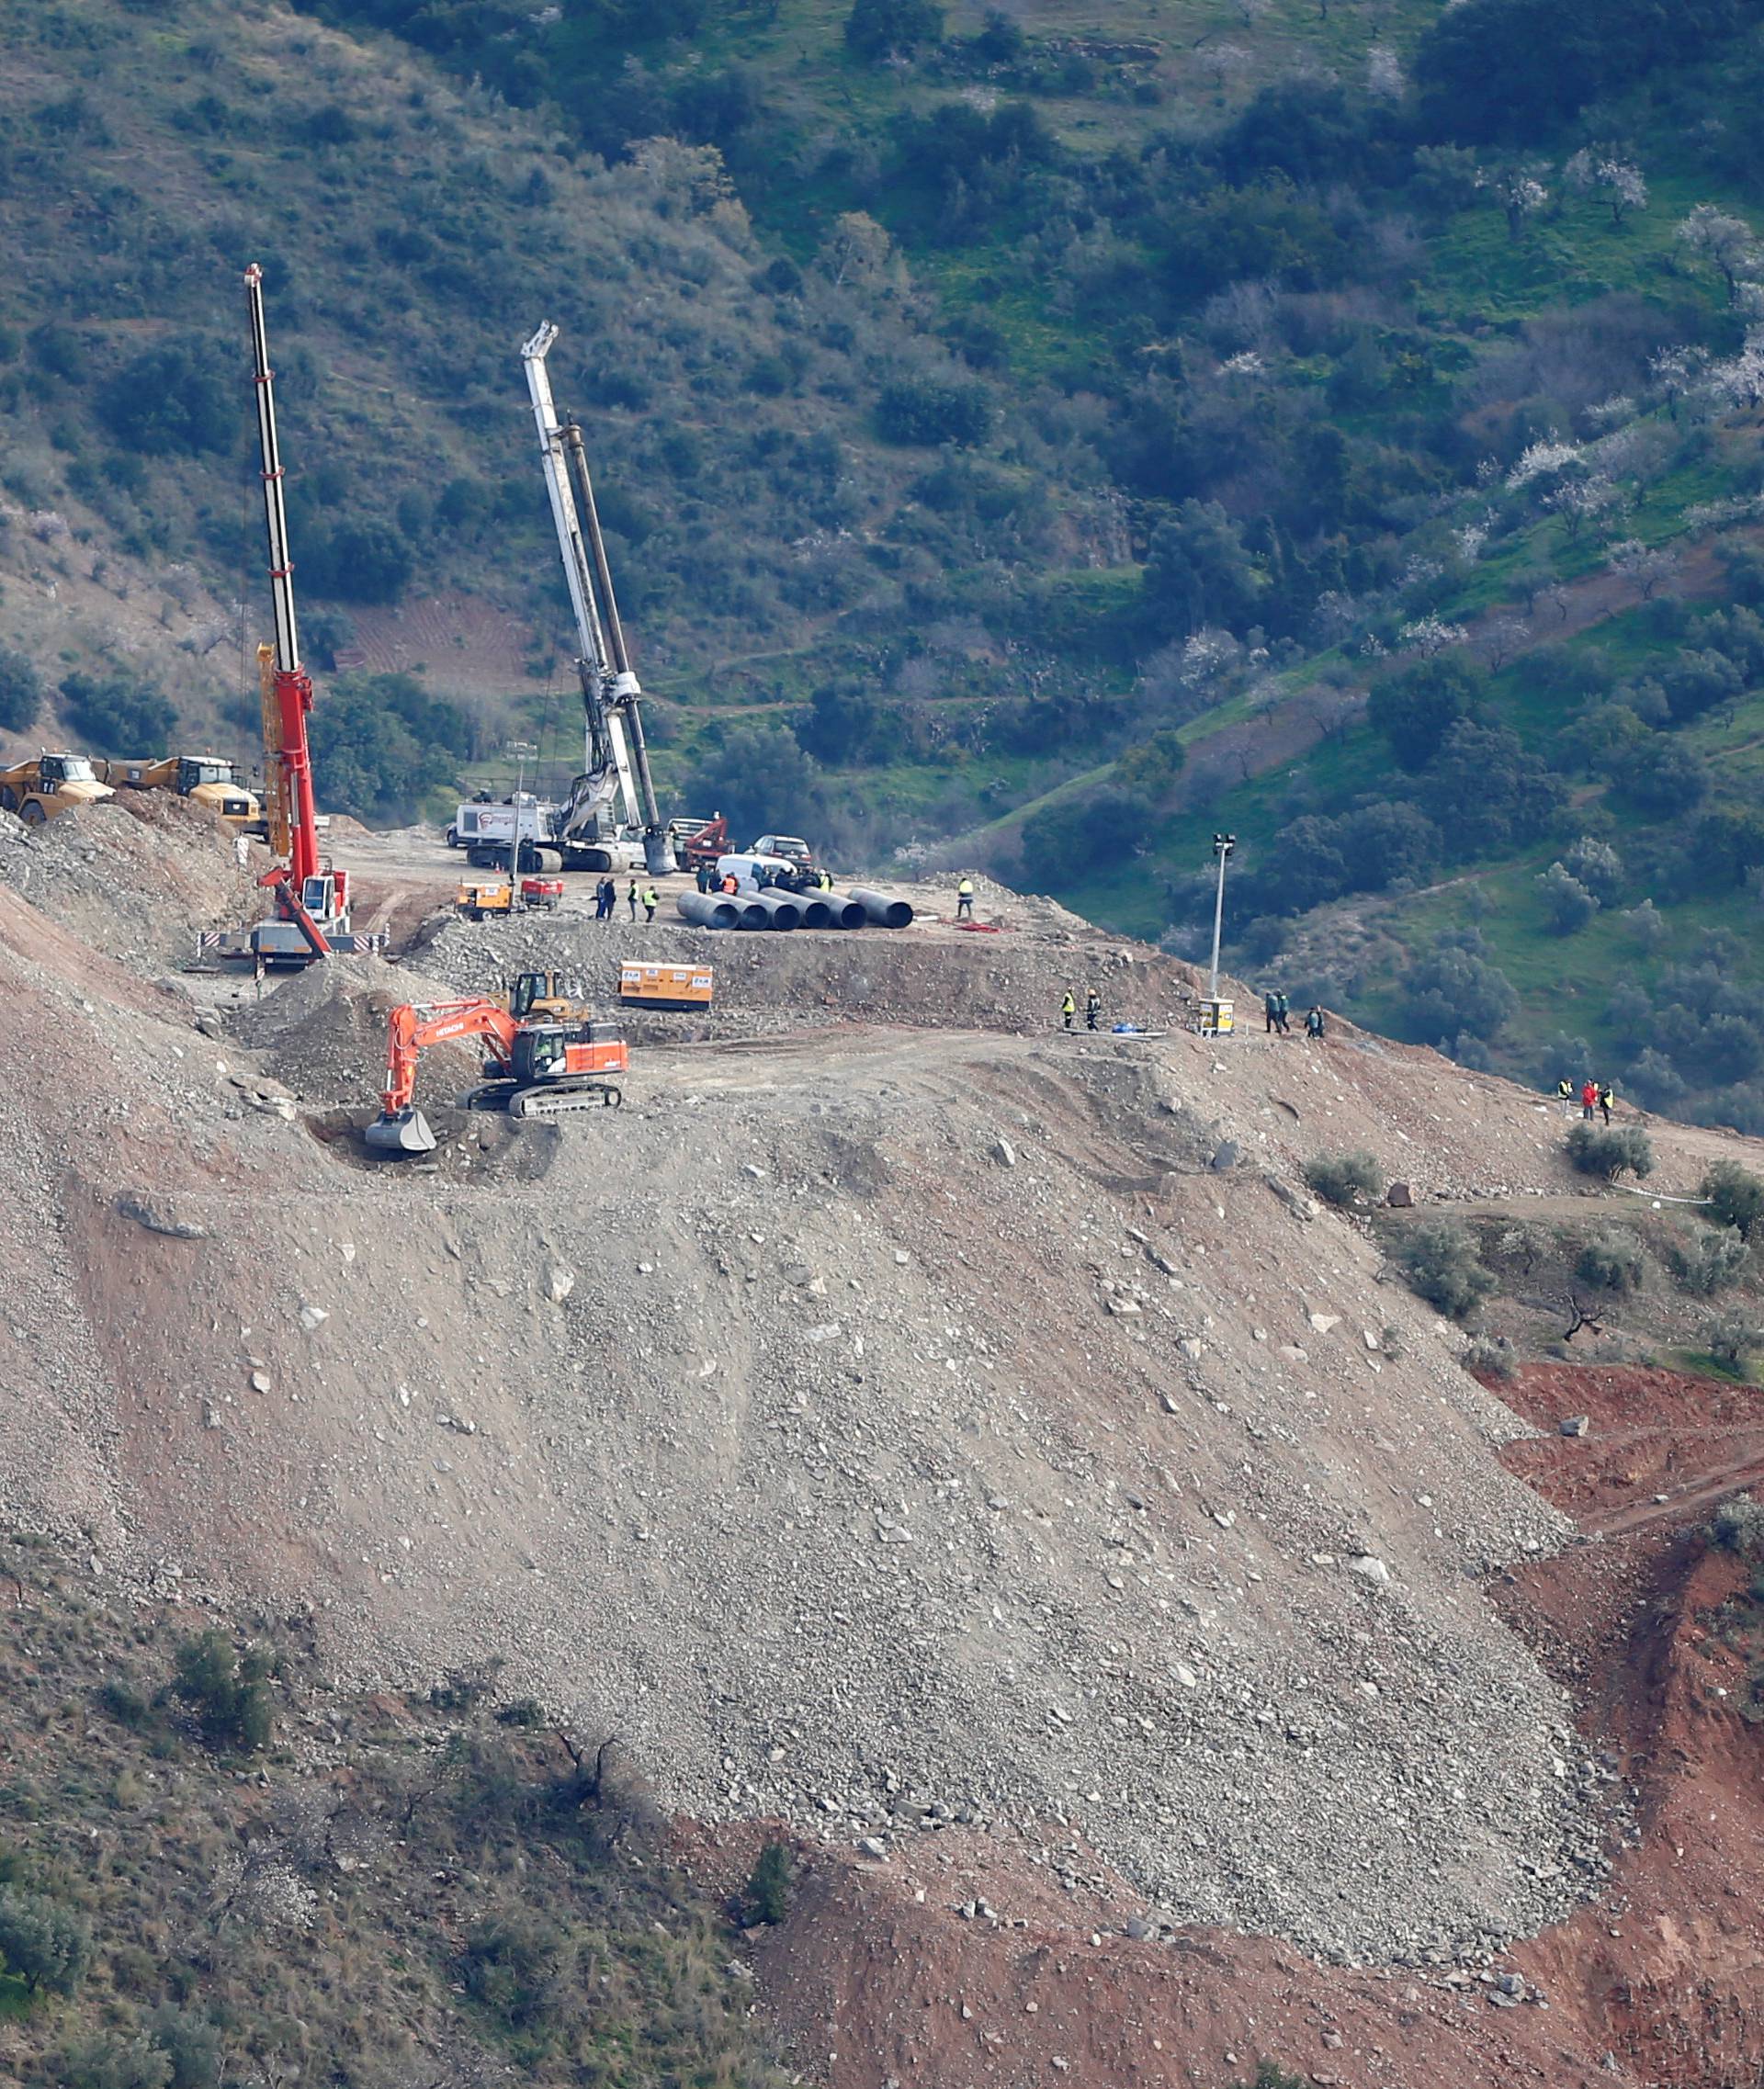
[0,0,1764,1122]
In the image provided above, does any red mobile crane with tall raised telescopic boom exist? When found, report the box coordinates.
[244,261,357,965]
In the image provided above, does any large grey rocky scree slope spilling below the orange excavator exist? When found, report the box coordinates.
[0,806,1663,1958]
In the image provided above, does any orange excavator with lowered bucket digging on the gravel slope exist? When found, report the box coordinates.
[366,999,631,1153]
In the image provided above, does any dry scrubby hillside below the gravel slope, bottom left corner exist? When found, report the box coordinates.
[0,1538,786,2089]
